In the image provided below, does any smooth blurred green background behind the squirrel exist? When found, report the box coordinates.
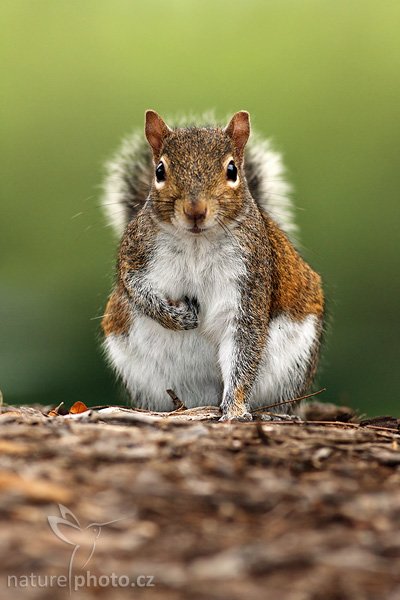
[0,0,400,416]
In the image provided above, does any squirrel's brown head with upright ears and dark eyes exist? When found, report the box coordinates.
[145,110,250,234]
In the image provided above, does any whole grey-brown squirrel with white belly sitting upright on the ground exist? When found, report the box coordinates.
[102,110,324,421]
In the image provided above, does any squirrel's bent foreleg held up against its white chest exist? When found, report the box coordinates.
[124,271,199,331]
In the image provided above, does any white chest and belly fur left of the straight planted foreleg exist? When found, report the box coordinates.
[105,233,245,410]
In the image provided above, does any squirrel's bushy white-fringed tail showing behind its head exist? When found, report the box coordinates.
[103,118,297,242]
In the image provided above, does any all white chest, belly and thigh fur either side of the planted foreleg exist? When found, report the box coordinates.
[105,234,318,410]
